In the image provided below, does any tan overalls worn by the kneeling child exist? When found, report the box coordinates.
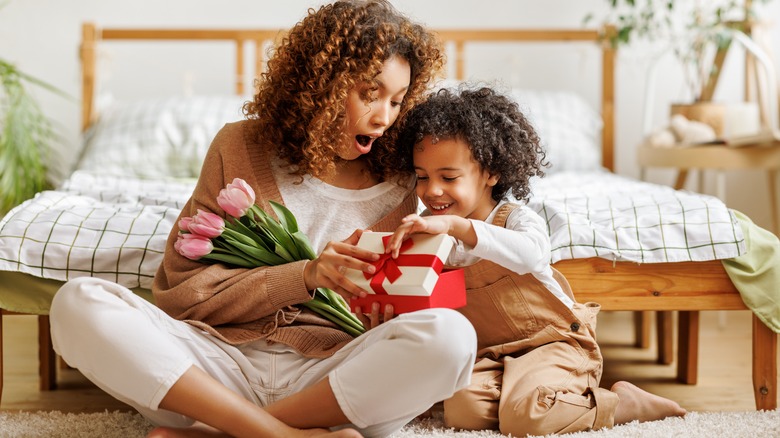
[444,204,618,436]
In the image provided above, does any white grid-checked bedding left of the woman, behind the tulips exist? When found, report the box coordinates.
[0,171,194,288]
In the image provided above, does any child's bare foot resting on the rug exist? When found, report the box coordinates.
[610,381,686,424]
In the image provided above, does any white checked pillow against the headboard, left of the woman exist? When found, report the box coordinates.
[76,96,247,179]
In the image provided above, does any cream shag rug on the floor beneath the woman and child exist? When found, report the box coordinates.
[0,411,780,438]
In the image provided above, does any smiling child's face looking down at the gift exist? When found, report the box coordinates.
[412,136,498,220]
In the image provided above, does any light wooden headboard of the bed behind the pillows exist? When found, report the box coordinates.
[81,23,615,170]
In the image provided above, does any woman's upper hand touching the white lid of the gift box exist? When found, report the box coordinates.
[303,230,379,301]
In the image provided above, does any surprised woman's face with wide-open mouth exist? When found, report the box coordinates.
[338,56,412,160]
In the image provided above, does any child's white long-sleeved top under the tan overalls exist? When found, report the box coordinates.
[442,201,574,309]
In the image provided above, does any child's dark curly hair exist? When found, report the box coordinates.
[397,86,548,201]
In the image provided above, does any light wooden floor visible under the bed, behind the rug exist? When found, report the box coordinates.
[0,311,776,412]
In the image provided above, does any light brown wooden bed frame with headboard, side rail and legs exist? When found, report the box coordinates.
[0,23,777,410]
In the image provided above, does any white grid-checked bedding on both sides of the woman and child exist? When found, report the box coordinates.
[0,172,745,288]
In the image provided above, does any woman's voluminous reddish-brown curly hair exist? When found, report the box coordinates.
[244,0,444,180]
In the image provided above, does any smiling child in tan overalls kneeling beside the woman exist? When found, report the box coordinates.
[387,88,685,436]
